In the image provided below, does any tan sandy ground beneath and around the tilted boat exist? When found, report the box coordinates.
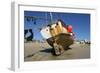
[24,42,90,62]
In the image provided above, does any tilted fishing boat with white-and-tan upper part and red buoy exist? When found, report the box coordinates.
[40,19,74,56]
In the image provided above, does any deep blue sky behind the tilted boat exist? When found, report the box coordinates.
[24,11,90,40]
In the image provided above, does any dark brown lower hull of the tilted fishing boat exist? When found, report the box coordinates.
[47,33,74,49]
